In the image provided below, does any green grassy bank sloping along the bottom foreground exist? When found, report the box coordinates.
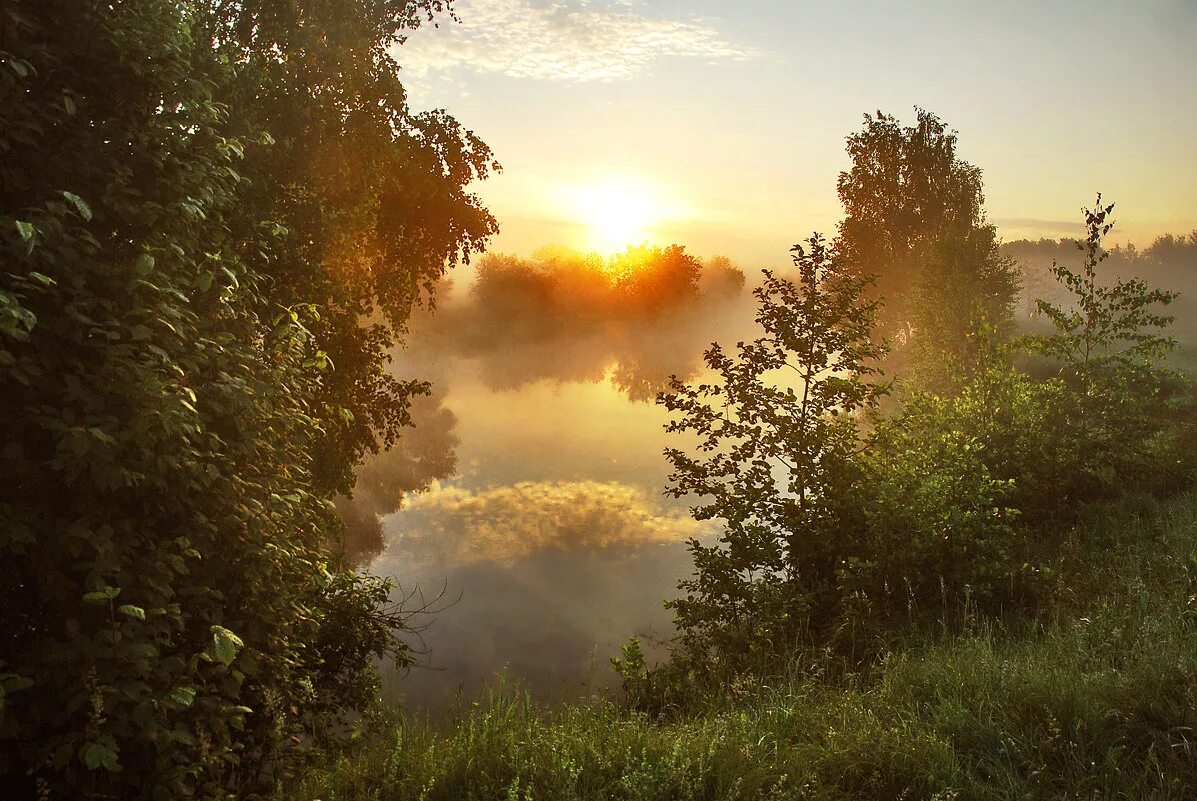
[279,493,1197,801]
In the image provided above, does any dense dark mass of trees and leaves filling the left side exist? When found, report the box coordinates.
[0,0,493,799]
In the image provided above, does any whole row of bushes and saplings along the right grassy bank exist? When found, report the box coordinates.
[661,195,1192,680]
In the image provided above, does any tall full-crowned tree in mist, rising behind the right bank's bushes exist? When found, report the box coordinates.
[836,109,1019,378]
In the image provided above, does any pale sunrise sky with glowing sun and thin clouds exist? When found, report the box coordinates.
[394,0,1197,266]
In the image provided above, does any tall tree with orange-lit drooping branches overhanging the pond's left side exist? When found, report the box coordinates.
[196,0,498,500]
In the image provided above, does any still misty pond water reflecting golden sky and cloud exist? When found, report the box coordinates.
[354,265,754,709]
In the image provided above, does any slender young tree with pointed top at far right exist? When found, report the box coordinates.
[1028,194,1177,499]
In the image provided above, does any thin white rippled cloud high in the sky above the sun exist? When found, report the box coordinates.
[395,0,753,81]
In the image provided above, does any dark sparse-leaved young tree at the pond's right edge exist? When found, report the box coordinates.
[658,235,883,660]
